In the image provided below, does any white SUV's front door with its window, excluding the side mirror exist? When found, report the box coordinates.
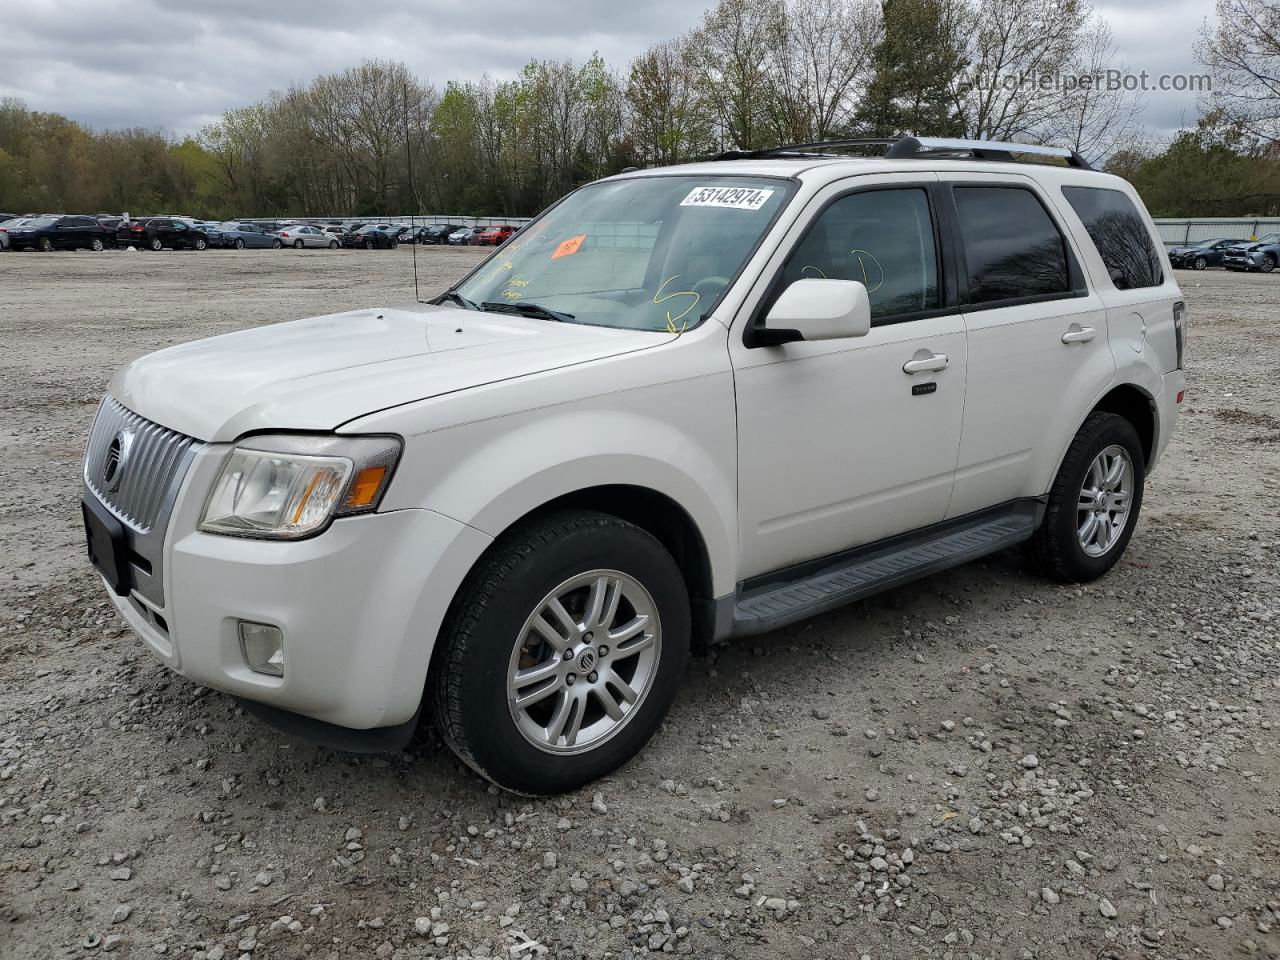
[730,174,966,579]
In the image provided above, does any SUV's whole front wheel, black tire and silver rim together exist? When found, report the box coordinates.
[430,512,690,795]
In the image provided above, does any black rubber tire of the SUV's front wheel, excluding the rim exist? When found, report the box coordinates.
[428,512,690,795]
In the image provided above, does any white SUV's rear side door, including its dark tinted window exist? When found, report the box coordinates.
[941,173,1115,516]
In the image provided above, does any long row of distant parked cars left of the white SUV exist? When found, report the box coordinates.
[0,214,516,251]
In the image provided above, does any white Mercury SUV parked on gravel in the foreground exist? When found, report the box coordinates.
[83,138,1184,794]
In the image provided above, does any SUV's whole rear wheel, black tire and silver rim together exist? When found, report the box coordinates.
[1030,411,1147,582]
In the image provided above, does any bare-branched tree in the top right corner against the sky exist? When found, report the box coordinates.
[1196,0,1280,143]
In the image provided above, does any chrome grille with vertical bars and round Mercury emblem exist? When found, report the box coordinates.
[84,397,196,535]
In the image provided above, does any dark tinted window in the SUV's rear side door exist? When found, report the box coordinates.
[955,187,1071,303]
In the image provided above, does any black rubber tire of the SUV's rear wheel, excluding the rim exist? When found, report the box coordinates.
[1030,411,1147,584]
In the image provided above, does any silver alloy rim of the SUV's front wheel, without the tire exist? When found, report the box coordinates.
[507,570,662,754]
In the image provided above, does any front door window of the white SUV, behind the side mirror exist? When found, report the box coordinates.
[778,187,940,321]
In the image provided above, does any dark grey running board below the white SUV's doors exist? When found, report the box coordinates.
[728,499,1044,636]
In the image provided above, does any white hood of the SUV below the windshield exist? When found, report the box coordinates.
[110,303,673,440]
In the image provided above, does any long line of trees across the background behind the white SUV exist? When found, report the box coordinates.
[0,0,1280,218]
